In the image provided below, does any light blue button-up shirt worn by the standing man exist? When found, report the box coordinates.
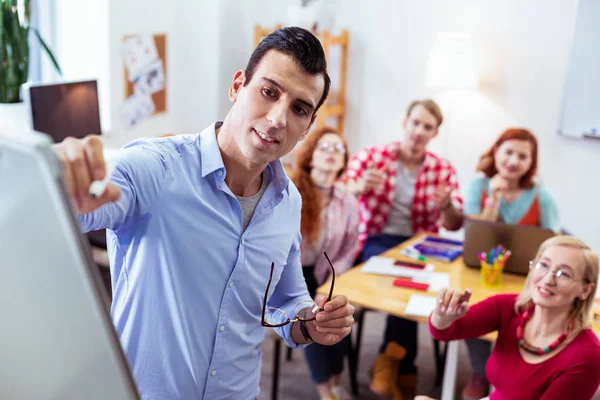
[79,124,310,400]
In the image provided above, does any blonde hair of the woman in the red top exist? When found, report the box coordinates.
[515,236,599,333]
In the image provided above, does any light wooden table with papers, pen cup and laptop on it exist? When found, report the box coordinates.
[318,234,600,400]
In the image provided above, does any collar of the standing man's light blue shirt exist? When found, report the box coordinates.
[200,121,289,192]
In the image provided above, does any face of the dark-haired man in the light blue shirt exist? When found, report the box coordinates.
[229,50,325,164]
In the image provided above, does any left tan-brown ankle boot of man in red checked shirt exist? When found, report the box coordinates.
[369,342,406,400]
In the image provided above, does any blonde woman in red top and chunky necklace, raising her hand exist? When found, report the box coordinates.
[419,236,600,400]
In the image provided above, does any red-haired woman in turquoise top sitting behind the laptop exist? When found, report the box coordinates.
[462,128,560,400]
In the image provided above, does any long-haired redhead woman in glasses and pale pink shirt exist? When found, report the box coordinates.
[292,127,358,400]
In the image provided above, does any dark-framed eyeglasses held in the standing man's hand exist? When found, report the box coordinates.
[261,252,335,328]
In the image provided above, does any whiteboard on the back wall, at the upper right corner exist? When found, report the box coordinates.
[559,0,600,138]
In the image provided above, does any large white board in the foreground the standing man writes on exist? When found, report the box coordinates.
[0,132,139,400]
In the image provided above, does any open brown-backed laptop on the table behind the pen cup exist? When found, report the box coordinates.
[463,218,554,275]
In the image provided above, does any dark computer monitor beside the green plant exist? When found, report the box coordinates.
[23,80,102,142]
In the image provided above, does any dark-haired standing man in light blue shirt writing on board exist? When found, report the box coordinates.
[55,28,354,400]
